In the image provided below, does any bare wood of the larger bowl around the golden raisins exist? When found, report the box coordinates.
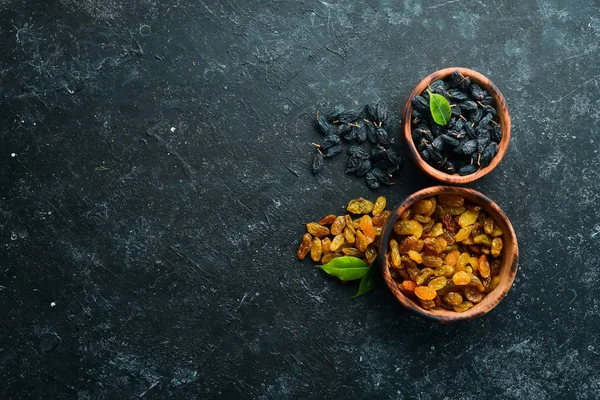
[379,186,519,324]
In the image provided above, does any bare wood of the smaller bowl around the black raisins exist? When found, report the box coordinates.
[402,68,510,185]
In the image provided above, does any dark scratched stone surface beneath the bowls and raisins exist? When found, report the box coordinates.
[0,0,600,399]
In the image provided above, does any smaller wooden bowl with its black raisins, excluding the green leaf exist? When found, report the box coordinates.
[402,68,510,184]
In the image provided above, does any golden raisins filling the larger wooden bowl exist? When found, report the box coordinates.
[388,194,503,312]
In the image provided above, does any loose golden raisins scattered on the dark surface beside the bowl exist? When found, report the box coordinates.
[298,196,390,264]
